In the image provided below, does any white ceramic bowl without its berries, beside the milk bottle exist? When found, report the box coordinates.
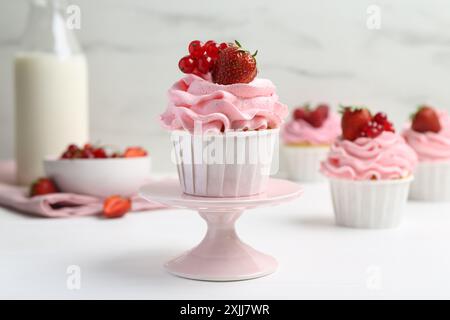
[44,156,151,198]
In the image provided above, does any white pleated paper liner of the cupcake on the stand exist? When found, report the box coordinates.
[172,129,279,197]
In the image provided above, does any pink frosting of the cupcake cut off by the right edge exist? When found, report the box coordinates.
[402,110,450,162]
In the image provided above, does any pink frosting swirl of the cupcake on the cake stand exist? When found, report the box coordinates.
[161,75,288,132]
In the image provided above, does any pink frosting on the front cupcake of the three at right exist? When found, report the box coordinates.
[321,131,417,180]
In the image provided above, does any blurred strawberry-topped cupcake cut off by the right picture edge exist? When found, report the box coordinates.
[403,106,450,201]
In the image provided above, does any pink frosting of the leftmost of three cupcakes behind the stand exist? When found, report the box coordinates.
[281,112,341,145]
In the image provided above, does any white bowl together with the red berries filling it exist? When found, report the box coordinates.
[44,143,151,198]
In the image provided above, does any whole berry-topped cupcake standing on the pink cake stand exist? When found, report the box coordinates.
[161,40,288,197]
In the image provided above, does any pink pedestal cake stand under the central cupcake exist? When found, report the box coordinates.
[140,179,303,281]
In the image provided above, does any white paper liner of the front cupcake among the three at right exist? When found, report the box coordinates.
[330,177,413,229]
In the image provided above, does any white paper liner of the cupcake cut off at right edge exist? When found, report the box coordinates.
[409,162,450,201]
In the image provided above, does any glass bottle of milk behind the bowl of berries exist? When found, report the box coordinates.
[14,0,89,185]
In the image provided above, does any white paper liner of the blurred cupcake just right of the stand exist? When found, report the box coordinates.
[283,145,330,182]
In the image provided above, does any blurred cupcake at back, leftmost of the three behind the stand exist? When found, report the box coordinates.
[281,104,341,182]
